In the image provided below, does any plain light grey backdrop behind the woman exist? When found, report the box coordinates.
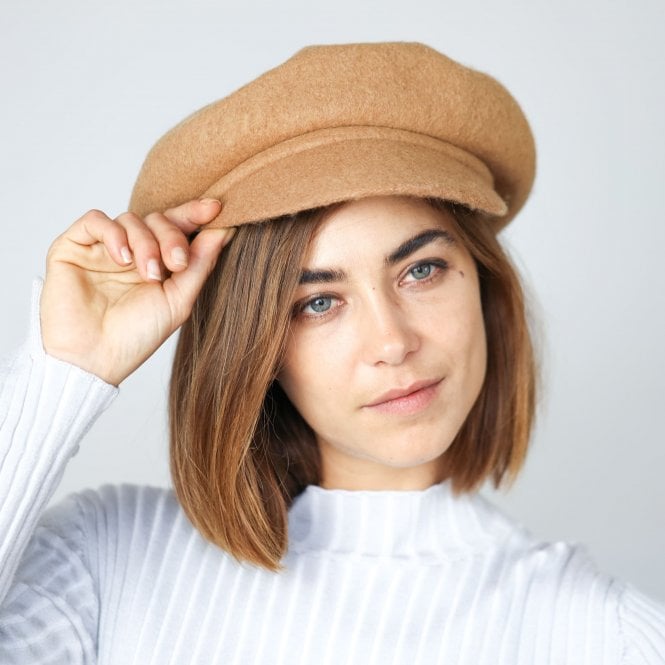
[0,0,665,599]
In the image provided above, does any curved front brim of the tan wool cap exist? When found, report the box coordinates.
[203,127,509,227]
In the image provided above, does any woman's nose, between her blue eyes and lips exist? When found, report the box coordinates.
[358,291,420,365]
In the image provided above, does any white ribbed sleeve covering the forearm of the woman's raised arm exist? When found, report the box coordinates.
[0,280,117,598]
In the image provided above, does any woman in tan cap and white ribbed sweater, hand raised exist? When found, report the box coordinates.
[0,44,665,663]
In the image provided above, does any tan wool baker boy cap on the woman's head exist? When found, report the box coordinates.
[130,42,535,228]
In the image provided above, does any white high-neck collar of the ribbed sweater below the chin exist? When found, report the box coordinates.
[289,482,526,559]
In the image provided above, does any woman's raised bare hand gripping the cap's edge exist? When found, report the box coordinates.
[41,199,233,385]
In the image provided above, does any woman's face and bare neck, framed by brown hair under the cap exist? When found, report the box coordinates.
[279,197,486,490]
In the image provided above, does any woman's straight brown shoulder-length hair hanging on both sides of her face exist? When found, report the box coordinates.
[169,199,536,570]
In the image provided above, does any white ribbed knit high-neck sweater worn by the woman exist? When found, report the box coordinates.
[0,282,665,665]
